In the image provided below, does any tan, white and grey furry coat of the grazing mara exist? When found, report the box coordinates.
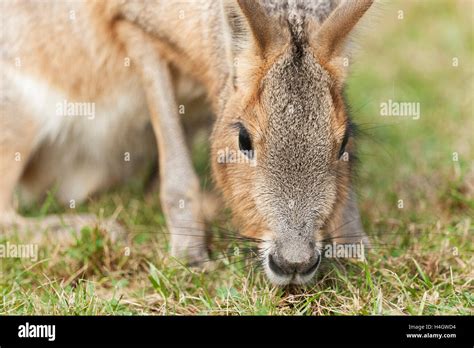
[0,0,371,284]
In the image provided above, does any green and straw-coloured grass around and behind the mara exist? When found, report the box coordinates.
[0,0,474,315]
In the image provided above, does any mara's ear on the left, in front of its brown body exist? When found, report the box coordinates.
[221,0,286,85]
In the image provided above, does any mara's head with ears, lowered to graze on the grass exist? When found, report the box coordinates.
[212,1,370,285]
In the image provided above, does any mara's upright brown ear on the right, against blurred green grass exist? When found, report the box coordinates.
[309,0,374,64]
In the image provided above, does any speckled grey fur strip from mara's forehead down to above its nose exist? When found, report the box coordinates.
[257,46,335,234]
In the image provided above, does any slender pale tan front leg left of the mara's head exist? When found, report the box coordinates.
[116,23,208,265]
